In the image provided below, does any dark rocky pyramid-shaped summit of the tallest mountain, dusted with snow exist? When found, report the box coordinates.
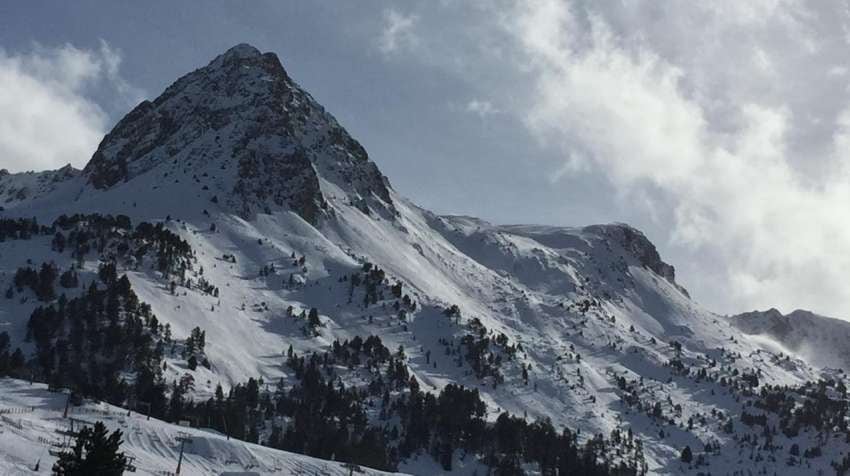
[84,44,393,222]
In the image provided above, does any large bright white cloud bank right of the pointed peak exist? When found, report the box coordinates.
[494,0,850,318]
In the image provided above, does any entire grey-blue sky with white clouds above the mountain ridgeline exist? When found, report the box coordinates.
[0,0,850,319]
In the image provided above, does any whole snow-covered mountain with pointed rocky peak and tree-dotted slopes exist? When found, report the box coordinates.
[0,45,850,474]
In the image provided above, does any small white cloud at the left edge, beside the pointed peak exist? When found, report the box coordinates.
[0,41,142,171]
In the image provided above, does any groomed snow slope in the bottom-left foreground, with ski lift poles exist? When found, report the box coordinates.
[0,379,400,476]
